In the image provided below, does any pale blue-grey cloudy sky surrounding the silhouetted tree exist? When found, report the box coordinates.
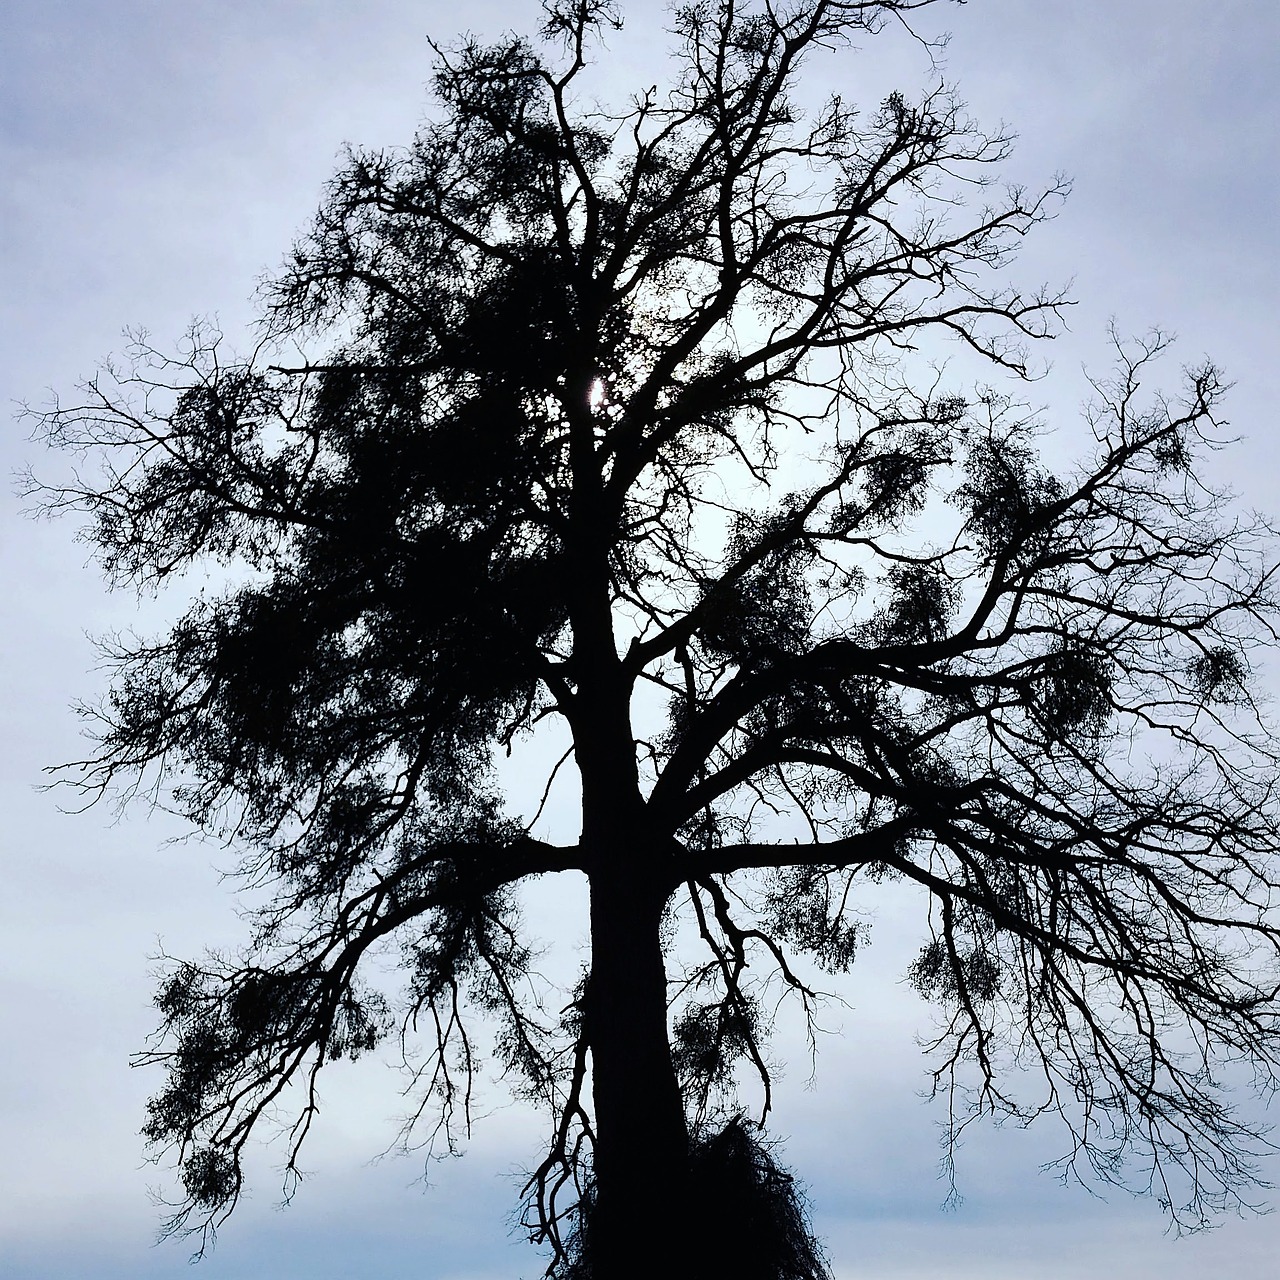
[0,0,1280,1280]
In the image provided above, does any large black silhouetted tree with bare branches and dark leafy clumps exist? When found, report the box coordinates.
[27,0,1280,1277]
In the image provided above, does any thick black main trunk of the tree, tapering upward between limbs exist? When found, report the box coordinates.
[573,517,703,1280]
